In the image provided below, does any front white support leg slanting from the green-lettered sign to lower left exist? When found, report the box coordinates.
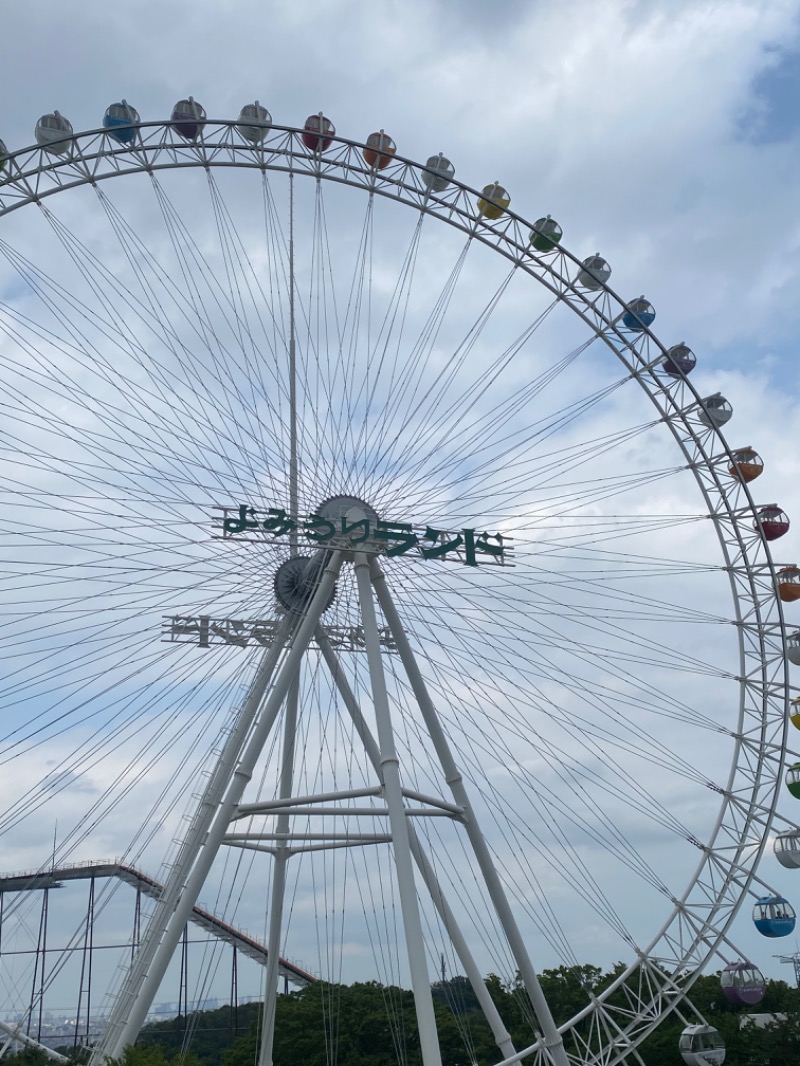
[99,551,341,1062]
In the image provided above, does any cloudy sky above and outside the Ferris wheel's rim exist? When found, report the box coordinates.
[0,0,800,1057]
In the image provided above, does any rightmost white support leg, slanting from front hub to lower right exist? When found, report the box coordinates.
[370,560,569,1066]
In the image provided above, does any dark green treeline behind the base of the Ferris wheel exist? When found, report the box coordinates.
[6,966,800,1066]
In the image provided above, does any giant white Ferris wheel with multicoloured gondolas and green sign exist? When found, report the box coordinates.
[0,98,800,1066]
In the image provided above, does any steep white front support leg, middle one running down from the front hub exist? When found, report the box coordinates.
[355,552,442,1066]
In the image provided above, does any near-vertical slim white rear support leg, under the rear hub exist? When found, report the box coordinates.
[258,674,300,1066]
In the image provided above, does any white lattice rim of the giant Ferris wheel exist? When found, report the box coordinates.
[0,112,788,1062]
